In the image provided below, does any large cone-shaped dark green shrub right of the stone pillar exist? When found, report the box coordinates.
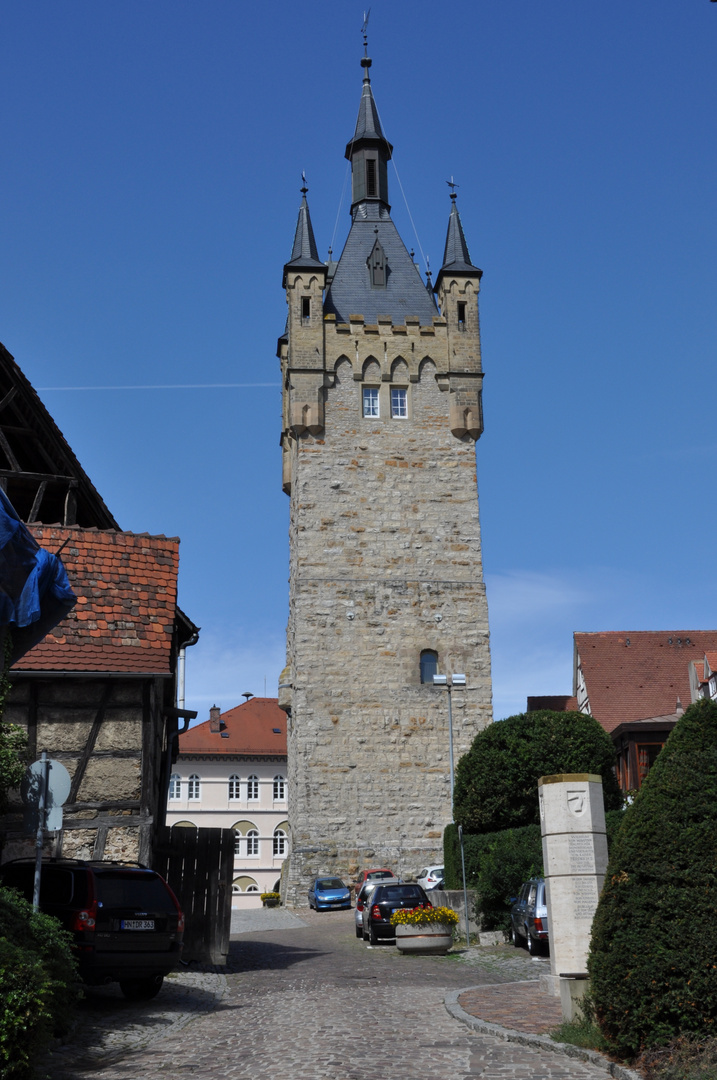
[589,701,717,1056]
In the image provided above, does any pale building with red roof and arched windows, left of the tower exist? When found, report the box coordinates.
[166,698,289,908]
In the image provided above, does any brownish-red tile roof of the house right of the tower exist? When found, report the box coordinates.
[574,630,717,731]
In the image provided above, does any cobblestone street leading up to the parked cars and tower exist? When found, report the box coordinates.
[45,912,608,1080]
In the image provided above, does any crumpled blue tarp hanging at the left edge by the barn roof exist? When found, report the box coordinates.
[0,488,77,663]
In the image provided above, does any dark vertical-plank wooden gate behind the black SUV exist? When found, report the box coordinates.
[152,826,235,963]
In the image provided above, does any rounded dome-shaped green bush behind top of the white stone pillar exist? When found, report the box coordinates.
[454,710,622,833]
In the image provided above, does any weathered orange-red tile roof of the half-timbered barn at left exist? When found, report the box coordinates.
[13,525,179,675]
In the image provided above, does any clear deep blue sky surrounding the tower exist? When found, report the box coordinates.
[0,0,717,718]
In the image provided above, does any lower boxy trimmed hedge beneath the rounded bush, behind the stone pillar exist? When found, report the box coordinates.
[444,810,624,932]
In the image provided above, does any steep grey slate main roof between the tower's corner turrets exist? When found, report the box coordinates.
[324,201,438,326]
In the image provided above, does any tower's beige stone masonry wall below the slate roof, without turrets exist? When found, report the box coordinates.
[286,316,491,903]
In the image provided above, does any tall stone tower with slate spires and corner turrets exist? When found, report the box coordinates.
[279,50,491,903]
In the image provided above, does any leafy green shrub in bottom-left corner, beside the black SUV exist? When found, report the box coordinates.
[0,888,77,1080]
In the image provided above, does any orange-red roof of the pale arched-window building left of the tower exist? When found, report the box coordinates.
[179,698,286,757]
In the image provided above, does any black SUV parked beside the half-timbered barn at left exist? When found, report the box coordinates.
[0,859,185,1000]
